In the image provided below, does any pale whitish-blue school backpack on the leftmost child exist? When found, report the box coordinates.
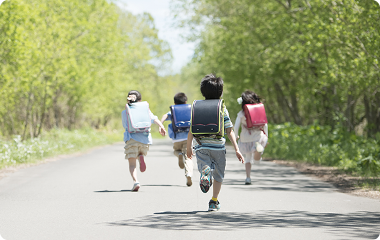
[125,102,152,133]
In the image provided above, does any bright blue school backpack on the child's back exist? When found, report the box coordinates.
[170,104,191,137]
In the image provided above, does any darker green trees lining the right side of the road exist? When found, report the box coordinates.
[174,0,380,136]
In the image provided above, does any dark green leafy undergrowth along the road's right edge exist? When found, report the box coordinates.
[265,123,380,177]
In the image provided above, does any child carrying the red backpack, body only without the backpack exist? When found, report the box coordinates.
[234,90,268,185]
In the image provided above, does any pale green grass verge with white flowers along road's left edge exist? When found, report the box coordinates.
[0,128,123,169]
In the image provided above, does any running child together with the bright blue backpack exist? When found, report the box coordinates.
[161,92,193,187]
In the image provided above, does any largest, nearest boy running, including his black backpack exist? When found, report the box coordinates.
[187,74,244,211]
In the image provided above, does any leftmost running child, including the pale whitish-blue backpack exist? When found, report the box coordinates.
[121,90,166,192]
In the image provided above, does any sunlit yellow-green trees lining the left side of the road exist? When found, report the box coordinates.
[0,0,186,139]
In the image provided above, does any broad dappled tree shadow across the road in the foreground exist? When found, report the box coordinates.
[106,211,380,239]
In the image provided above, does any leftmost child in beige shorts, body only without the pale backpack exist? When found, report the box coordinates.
[121,90,166,192]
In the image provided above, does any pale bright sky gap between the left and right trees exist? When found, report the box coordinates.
[119,0,195,74]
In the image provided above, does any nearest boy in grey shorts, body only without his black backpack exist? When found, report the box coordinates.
[187,74,244,211]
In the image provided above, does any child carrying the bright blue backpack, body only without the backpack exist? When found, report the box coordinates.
[161,92,193,187]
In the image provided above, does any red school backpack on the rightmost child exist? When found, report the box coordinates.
[243,103,268,129]
